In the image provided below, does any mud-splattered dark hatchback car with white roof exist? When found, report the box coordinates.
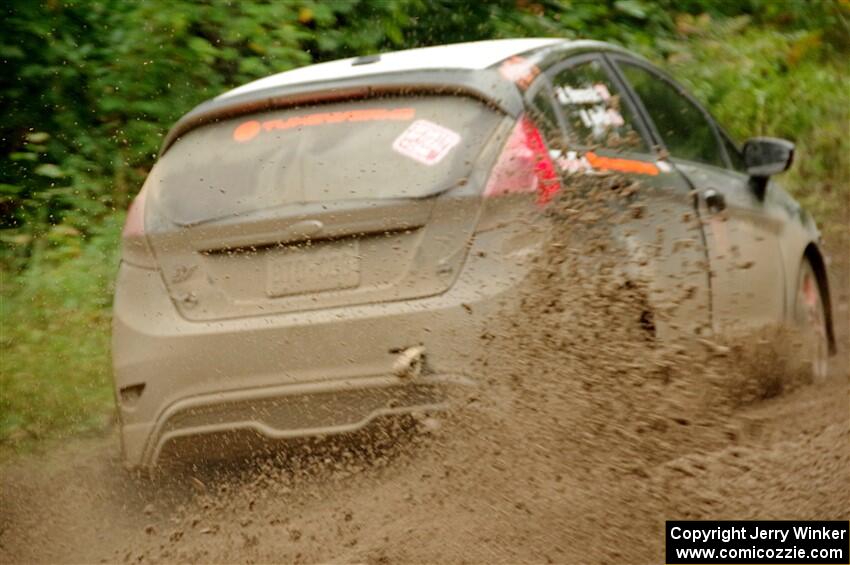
[113,39,834,466]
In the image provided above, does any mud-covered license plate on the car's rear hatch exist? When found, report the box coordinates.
[266,242,360,297]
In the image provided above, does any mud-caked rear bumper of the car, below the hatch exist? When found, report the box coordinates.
[113,229,525,467]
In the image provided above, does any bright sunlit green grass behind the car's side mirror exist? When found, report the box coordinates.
[662,17,850,231]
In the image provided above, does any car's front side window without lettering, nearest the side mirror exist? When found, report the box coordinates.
[619,62,726,168]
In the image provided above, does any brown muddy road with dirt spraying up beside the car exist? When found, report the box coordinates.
[0,177,850,563]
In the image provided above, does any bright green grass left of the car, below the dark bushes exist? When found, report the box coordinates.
[0,214,124,447]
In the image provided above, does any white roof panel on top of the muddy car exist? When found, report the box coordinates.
[218,39,563,99]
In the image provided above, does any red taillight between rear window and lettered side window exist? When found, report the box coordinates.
[484,115,561,204]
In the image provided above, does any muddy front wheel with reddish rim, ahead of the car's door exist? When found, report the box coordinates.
[794,259,829,380]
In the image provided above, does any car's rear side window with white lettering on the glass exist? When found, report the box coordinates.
[553,60,648,152]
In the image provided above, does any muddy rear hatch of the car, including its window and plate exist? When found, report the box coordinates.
[145,96,505,320]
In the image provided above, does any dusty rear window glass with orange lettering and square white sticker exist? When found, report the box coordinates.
[150,96,500,224]
